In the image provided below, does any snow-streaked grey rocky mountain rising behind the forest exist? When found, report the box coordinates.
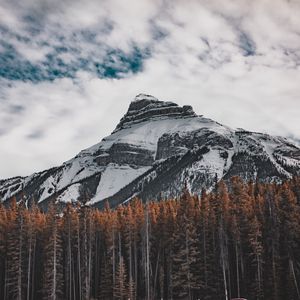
[0,94,300,208]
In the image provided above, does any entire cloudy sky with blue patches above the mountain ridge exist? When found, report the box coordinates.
[0,0,300,178]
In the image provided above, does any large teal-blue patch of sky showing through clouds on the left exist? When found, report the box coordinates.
[0,35,150,82]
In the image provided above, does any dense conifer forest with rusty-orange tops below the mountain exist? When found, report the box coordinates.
[0,177,300,300]
